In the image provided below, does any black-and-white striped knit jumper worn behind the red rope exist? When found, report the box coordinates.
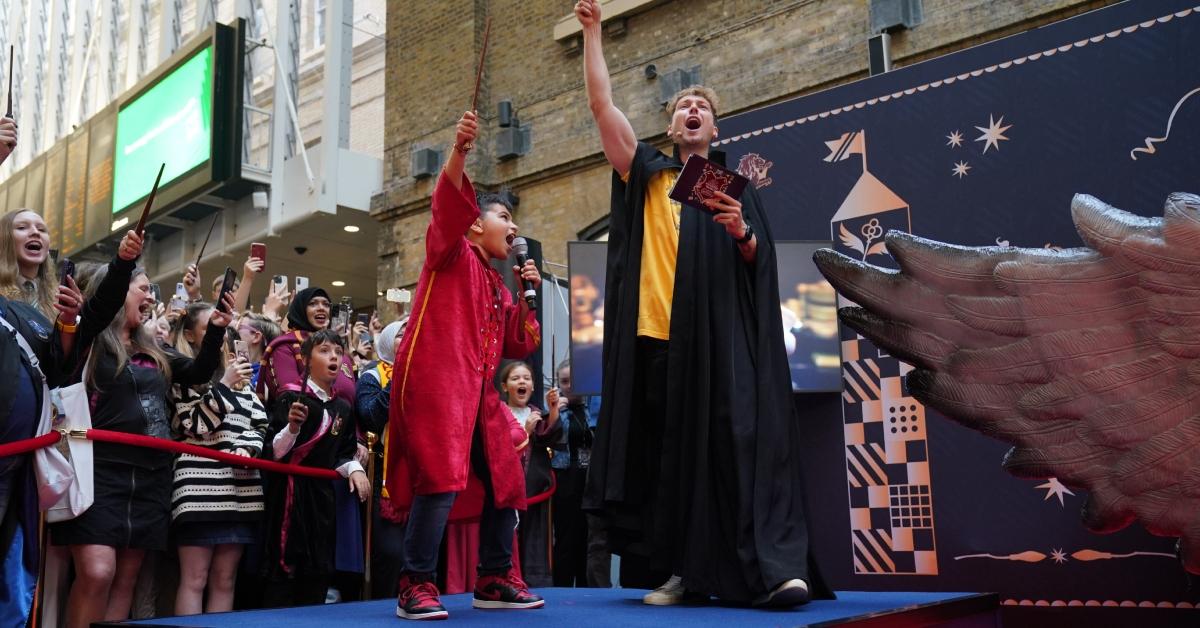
[170,383,269,524]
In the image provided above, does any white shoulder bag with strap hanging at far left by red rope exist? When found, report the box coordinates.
[0,316,95,522]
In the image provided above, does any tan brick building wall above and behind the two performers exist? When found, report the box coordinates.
[372,0,1112,304]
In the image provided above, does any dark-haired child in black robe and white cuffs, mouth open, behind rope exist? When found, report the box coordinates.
[264,329,371,608]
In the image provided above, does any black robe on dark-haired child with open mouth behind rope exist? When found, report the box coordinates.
[263,387,358,580]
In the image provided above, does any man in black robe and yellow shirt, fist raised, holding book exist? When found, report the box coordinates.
[575,0,829,608]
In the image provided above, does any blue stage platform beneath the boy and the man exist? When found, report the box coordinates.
[117,588,1000,628]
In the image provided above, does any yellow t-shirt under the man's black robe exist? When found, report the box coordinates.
[637,168,680,340]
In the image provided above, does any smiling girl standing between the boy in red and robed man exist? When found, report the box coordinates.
[500,361,562,586]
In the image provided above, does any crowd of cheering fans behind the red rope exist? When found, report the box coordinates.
[0,199,611,626]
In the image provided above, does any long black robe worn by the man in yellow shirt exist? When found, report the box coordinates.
[584,143,828,602]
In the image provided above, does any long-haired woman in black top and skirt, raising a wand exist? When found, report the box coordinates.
[49,231,233,627]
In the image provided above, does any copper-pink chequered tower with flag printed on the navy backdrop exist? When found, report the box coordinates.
[824,131,937,575]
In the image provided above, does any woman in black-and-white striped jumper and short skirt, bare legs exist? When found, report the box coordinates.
[172,303,268,615]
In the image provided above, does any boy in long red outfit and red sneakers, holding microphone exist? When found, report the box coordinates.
[386,112,545,620]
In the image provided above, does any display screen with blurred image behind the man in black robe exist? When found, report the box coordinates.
[568,240,841,395]
